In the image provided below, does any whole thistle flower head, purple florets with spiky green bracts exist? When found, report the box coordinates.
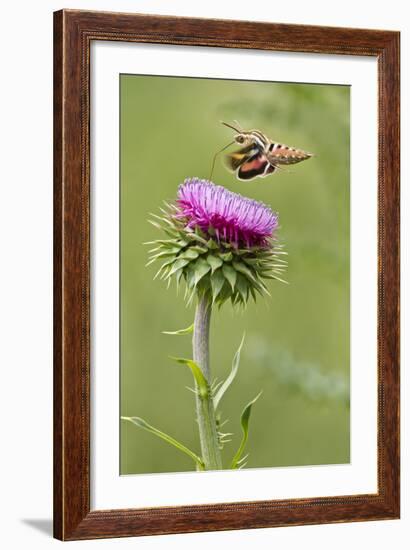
[148,178,286,305]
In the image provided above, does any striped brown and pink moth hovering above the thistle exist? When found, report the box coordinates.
[211,121,313,181]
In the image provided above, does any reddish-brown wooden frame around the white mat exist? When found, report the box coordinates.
[54,10,400,540]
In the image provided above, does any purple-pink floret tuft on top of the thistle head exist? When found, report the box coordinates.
[177,178,278,247]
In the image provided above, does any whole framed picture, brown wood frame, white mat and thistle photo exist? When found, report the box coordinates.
[54,10,400,540]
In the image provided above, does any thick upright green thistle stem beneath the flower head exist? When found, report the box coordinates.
[192,295,222,470]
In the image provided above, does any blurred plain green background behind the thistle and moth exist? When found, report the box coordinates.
[120,75,350,474]
